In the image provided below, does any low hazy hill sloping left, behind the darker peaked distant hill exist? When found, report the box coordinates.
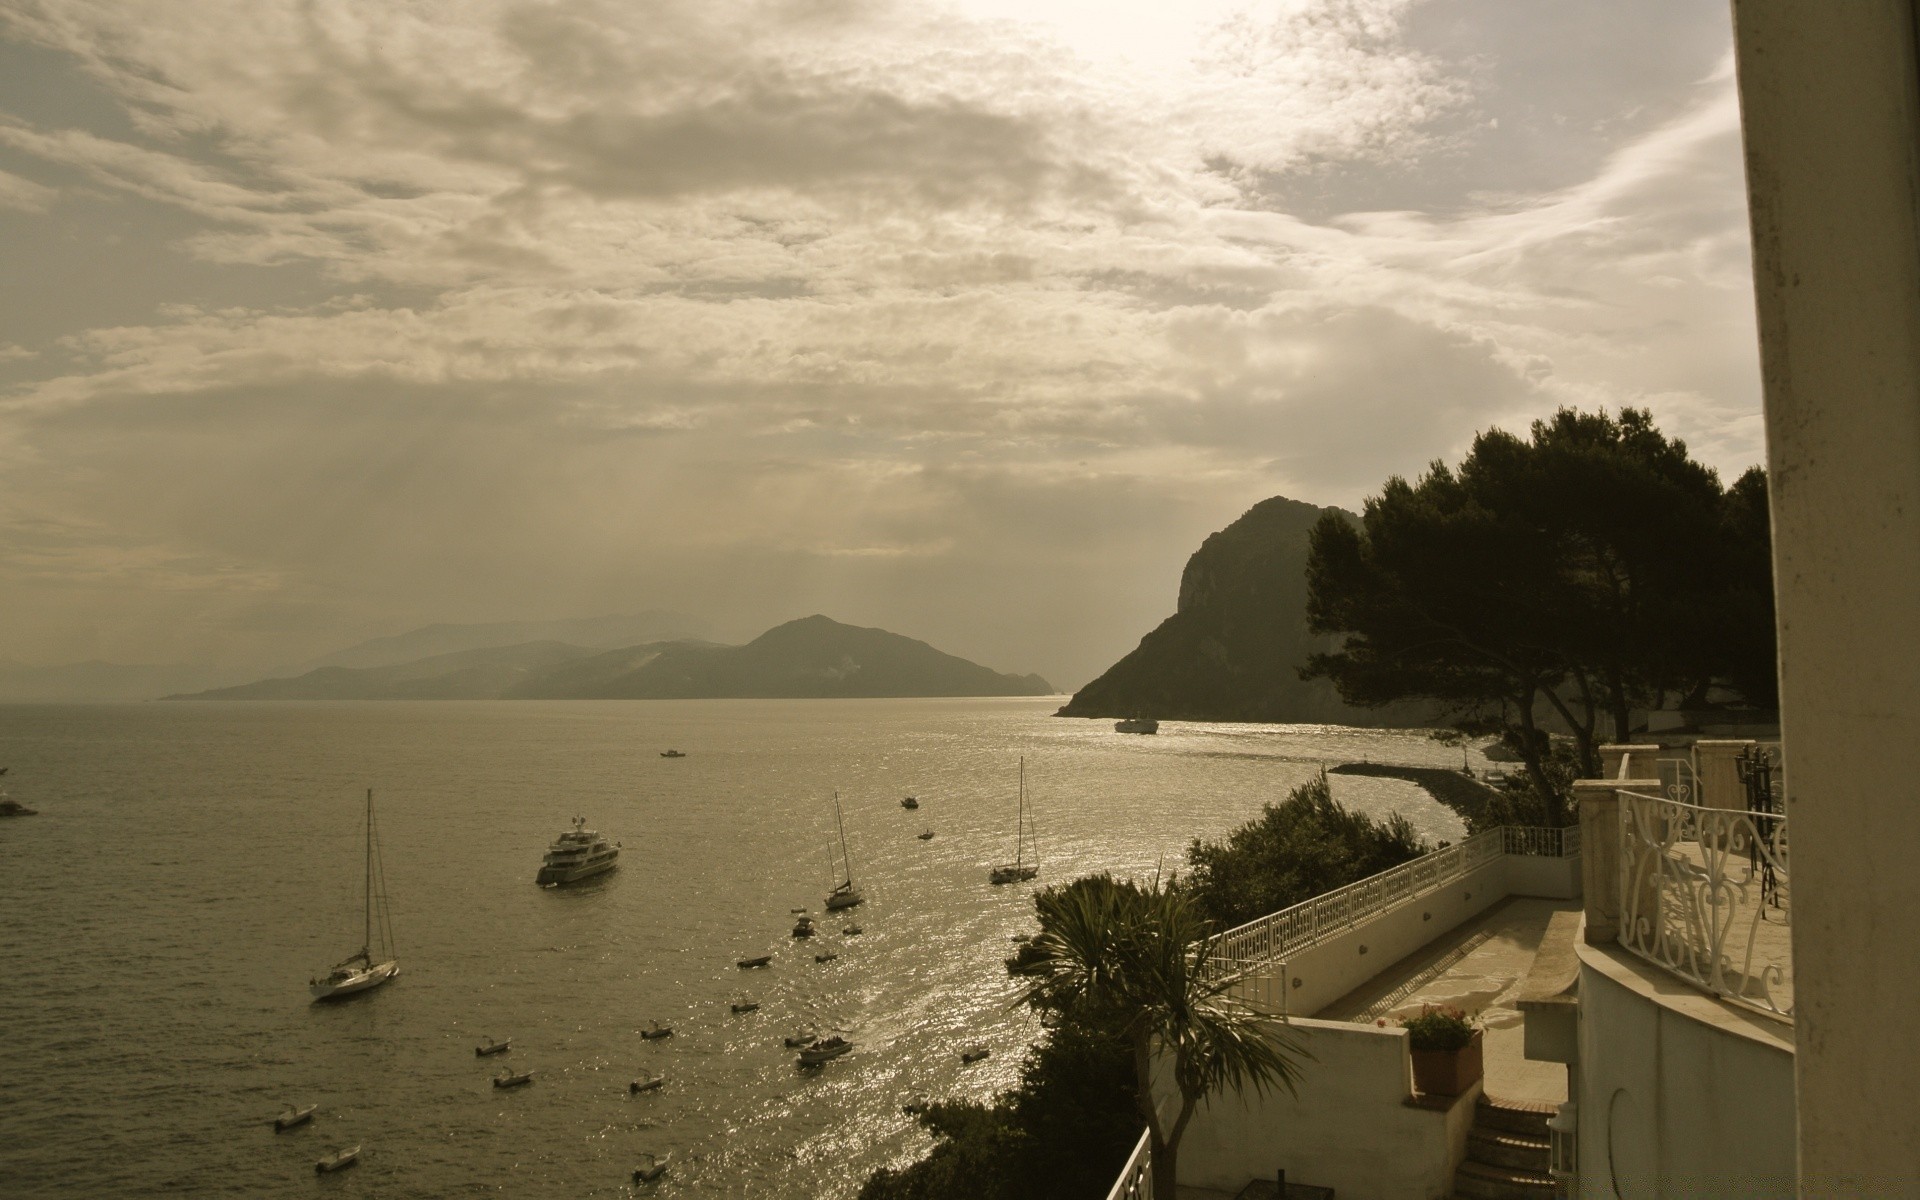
[165,641,597,701]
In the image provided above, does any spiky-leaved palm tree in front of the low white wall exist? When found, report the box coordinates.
[1023,876,1304,1200]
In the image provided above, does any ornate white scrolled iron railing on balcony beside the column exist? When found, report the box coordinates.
[1620,791,1793,1021]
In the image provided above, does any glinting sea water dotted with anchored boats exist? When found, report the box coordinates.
[0,699,1461,1198]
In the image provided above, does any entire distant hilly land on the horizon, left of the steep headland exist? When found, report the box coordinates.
[163,616,1054,701]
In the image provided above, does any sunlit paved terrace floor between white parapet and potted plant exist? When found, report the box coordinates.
[1313,897,1580,1104]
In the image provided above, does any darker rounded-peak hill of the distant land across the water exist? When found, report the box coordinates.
[513,616,1054,699]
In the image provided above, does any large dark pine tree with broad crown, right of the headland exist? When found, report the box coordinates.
[1302,409,1772,820]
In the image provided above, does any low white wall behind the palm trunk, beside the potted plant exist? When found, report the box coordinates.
[1160,1020,1480,1200]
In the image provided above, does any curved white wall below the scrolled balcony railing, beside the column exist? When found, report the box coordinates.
[1576,943,1795,1200]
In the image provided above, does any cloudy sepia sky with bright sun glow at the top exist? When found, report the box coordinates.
[0,0,1763,689]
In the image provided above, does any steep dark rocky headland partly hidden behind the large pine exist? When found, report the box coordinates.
[1060,495,1423,726]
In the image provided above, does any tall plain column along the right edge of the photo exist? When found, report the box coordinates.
[1734,0,1920,1196]
